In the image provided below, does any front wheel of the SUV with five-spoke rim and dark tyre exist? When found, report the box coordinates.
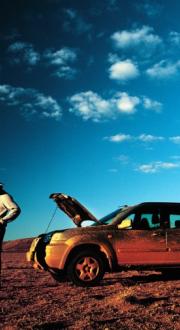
[67,249,105,287]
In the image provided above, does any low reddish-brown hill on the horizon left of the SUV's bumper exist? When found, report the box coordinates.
[3,238,33,252]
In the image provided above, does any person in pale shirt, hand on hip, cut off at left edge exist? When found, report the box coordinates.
[0,183,21,245]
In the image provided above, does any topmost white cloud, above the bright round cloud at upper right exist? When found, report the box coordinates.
[111,26,162,49]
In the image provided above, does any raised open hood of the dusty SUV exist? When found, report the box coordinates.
[49,193,99,227]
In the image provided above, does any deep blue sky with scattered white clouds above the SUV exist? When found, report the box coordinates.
[0,0,180,239]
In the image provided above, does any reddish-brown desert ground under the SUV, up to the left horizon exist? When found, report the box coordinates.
[0,239,180,330]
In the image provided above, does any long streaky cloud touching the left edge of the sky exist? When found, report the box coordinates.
[0,85,62,120]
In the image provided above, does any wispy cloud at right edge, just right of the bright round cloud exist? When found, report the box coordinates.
[146,60,180,79]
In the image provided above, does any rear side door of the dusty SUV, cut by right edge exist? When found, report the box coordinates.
[165,205,180,266]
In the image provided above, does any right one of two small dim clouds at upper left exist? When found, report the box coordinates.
[44,47,77,79]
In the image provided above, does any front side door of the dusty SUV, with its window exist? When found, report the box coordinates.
[112,208,167,265]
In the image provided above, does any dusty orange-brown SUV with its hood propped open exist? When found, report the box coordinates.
[27,193,180,286]
